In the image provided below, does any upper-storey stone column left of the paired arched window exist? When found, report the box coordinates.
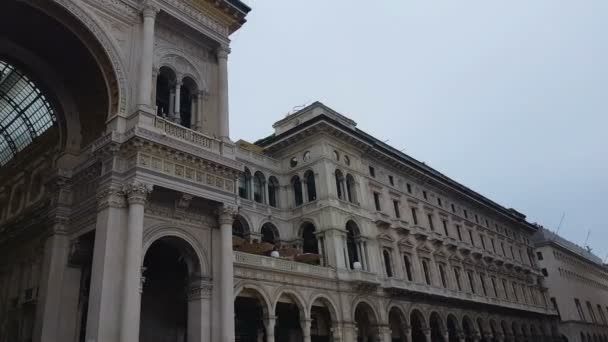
[137,1,158,110]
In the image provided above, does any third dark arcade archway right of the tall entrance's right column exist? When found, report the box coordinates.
[310,297,338,342]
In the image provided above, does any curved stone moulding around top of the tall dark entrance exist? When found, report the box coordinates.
[142,224,211,276]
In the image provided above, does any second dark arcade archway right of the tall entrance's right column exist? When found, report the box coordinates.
[274,293,306,342]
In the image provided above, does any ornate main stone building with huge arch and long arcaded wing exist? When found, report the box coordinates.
[0,0,559,342]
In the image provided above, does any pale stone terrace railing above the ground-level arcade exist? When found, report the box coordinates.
[234,252,336,279]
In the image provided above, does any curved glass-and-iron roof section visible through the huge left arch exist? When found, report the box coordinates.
[0,59,56,165]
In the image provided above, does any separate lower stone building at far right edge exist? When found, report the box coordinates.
[533,228,608,342]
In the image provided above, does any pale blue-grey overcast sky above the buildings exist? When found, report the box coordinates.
[229,0,608,259]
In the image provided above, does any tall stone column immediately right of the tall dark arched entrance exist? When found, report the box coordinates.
[219,205,236,342]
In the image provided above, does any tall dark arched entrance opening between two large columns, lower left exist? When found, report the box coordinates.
[139,237,203,342]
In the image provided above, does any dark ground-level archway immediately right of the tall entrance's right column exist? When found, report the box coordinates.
[234,288,268,342]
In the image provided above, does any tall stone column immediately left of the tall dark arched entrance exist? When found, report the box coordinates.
[120,182,151,342]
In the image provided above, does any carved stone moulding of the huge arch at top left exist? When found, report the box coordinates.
[25,0,128,117]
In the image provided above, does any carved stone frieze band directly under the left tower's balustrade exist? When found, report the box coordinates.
[137,152,234,193]
